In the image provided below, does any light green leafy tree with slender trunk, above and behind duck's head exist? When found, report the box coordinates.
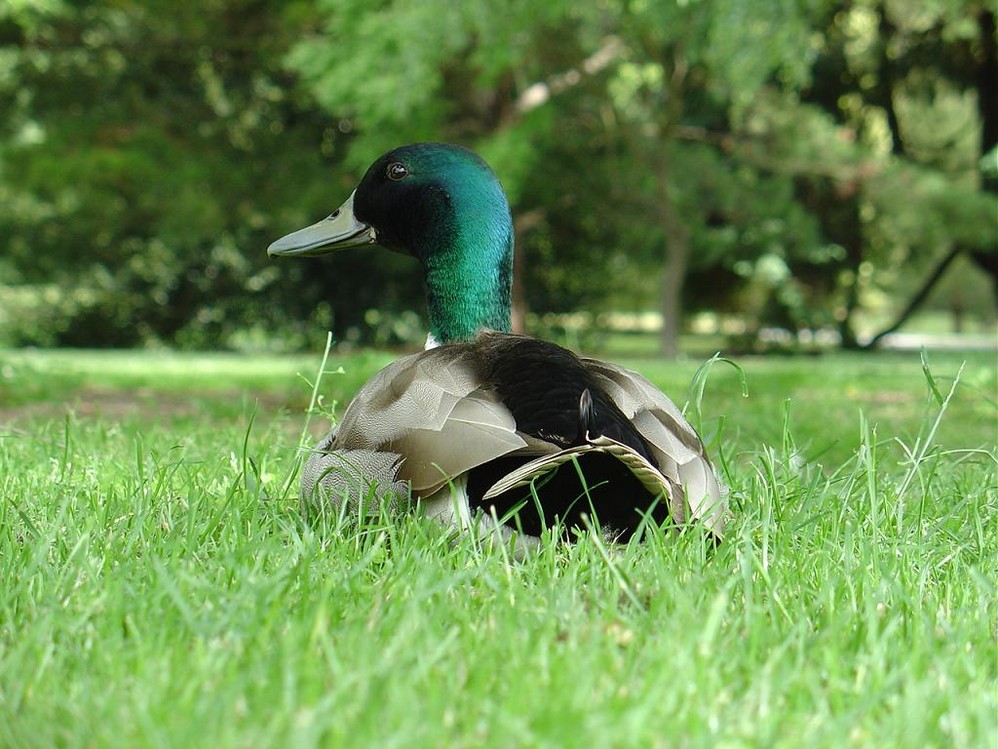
[291,0,828,355]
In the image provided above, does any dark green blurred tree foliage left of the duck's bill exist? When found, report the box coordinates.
[0,0,356,346]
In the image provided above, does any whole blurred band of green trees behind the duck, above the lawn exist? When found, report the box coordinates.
[0,0,998,355]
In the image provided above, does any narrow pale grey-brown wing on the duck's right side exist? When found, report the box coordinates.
[582,358,728,536]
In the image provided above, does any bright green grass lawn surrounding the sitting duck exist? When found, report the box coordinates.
[0,344,998,749]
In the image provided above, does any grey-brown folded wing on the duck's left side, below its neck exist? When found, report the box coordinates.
[326,347,543,497]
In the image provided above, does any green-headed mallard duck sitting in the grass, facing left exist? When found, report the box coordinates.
[267,142,728,549]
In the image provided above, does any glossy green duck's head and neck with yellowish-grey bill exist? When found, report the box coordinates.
[267,143,513,343]
